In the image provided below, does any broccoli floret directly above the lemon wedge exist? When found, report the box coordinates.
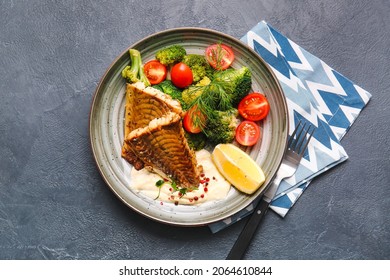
[204,108,239,145]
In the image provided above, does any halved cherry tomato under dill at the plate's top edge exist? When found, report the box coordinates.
[205,44,234,70]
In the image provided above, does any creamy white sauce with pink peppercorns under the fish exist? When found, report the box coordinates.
[131,149,230,204]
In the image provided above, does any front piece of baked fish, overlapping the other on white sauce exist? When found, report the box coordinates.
[125,112,202,188]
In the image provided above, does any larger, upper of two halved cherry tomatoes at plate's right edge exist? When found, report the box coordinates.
[238,92,270,121]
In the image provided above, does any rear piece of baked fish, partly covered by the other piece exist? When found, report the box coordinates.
[122,82,183,170]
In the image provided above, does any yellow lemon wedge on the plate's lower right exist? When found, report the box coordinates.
[211,144,265,194]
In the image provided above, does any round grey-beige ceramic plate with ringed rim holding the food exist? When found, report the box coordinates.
[89,28,288,226]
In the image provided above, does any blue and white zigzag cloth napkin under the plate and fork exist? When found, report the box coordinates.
[209,21,371,233]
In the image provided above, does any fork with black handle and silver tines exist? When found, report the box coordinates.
[226,121,315,260]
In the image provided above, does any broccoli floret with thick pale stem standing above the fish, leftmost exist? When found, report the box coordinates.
[122,49,150,86]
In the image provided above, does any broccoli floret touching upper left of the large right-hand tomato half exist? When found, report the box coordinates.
[214,66,252,107]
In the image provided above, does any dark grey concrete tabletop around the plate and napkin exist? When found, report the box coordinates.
[0,0,390,259]
